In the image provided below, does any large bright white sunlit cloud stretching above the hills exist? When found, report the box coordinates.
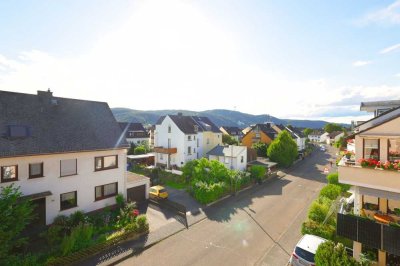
[0,1,400,124]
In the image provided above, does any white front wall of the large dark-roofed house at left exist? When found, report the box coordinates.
[0,149,126,224]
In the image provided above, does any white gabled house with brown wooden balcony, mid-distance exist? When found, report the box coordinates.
[154,113,222,168]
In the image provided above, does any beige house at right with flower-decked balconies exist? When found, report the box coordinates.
[337,103,400,265]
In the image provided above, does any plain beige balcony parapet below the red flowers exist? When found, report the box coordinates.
[339,164,400,193]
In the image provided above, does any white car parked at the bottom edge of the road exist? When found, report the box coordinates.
[289,235,327,266]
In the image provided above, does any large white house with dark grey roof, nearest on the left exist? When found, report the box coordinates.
[0,91,148,227]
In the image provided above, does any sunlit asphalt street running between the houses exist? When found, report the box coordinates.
[120,148,333,266]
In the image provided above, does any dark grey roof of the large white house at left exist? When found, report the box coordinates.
[0,91,127,157]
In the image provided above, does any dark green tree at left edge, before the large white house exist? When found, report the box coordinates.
[0,184,34,265]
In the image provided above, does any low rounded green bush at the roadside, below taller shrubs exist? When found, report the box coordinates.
[193,181,226,204]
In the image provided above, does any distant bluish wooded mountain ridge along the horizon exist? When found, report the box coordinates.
[111,108,334,129]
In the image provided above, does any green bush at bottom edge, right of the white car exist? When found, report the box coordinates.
[315,241,360,266]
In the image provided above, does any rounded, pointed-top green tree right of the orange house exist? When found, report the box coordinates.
[267,130,298,167]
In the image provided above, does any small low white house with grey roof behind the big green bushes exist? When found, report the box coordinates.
[207,145,247,171]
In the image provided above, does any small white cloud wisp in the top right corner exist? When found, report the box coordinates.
[362,0,400,25]
